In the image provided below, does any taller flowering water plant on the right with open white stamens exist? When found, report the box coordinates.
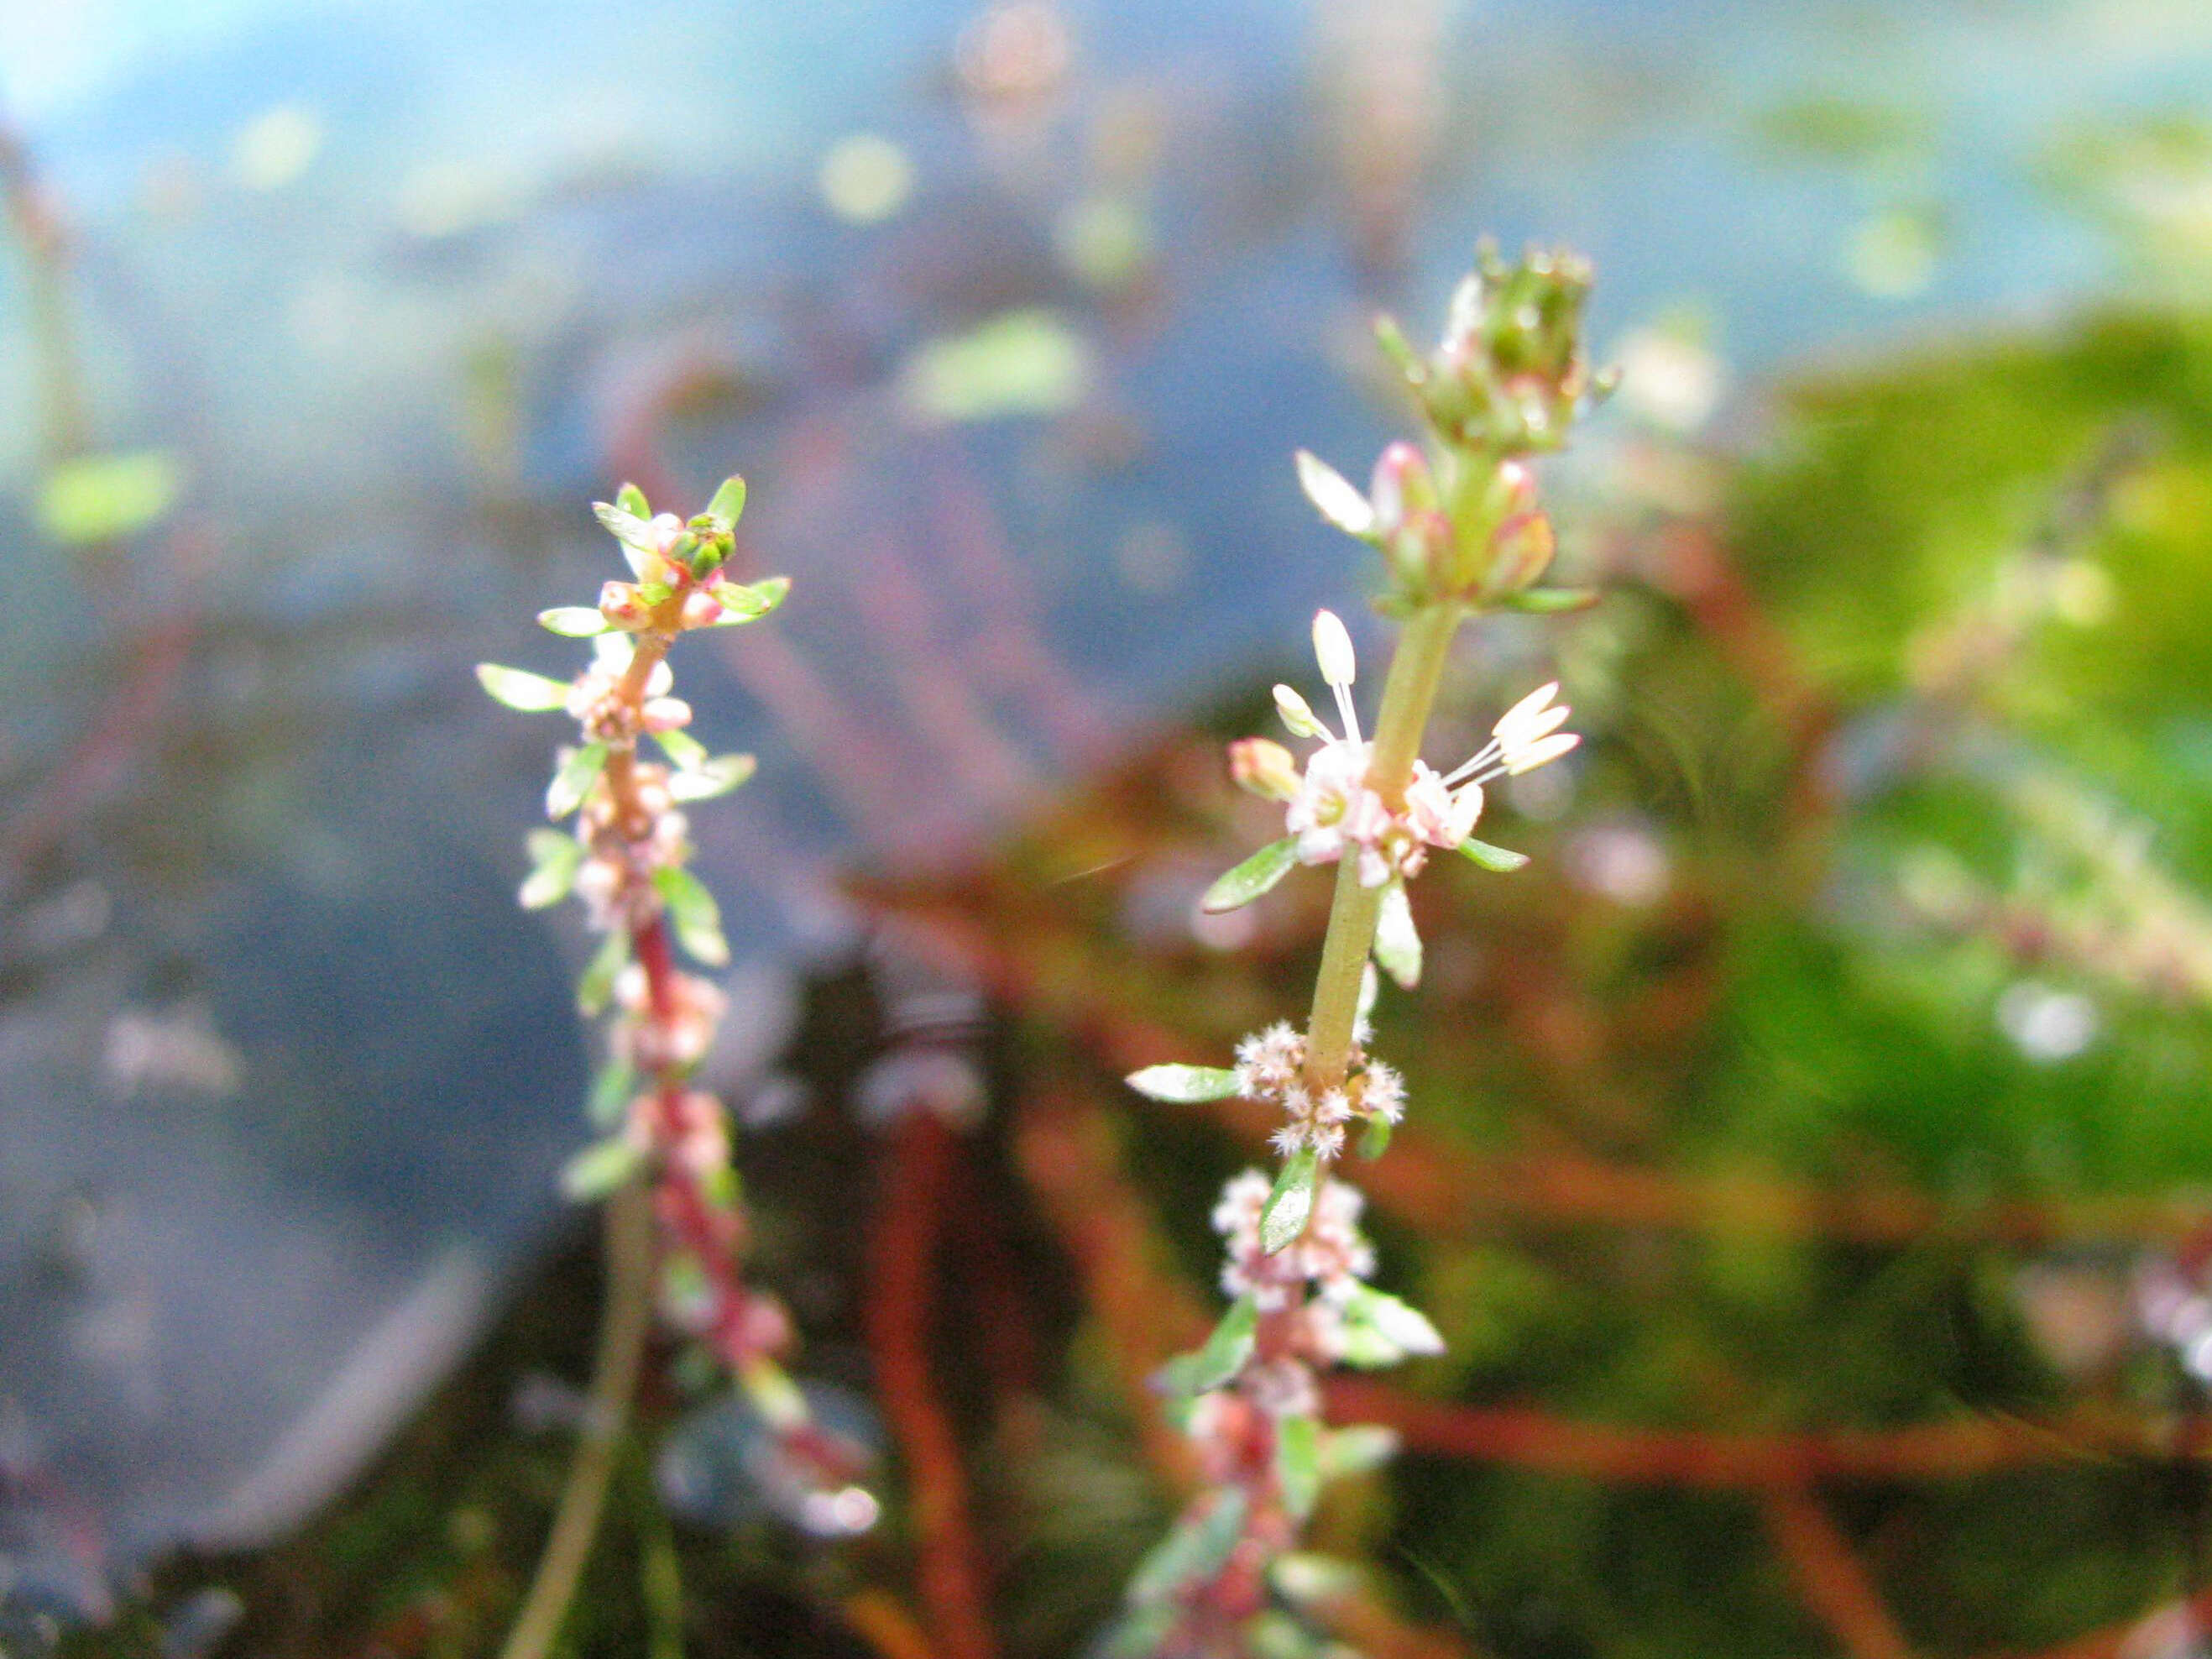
[1108,248,1606,1659]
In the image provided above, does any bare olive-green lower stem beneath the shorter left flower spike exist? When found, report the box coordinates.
[500,1184,652,1659]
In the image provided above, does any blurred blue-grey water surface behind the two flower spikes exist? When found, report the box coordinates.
[0,0,2212,1610]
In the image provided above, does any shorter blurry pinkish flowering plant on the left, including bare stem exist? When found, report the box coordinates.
[476,478,876,1659]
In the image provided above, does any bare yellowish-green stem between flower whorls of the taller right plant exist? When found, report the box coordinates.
[1305,599,1464,1091]
